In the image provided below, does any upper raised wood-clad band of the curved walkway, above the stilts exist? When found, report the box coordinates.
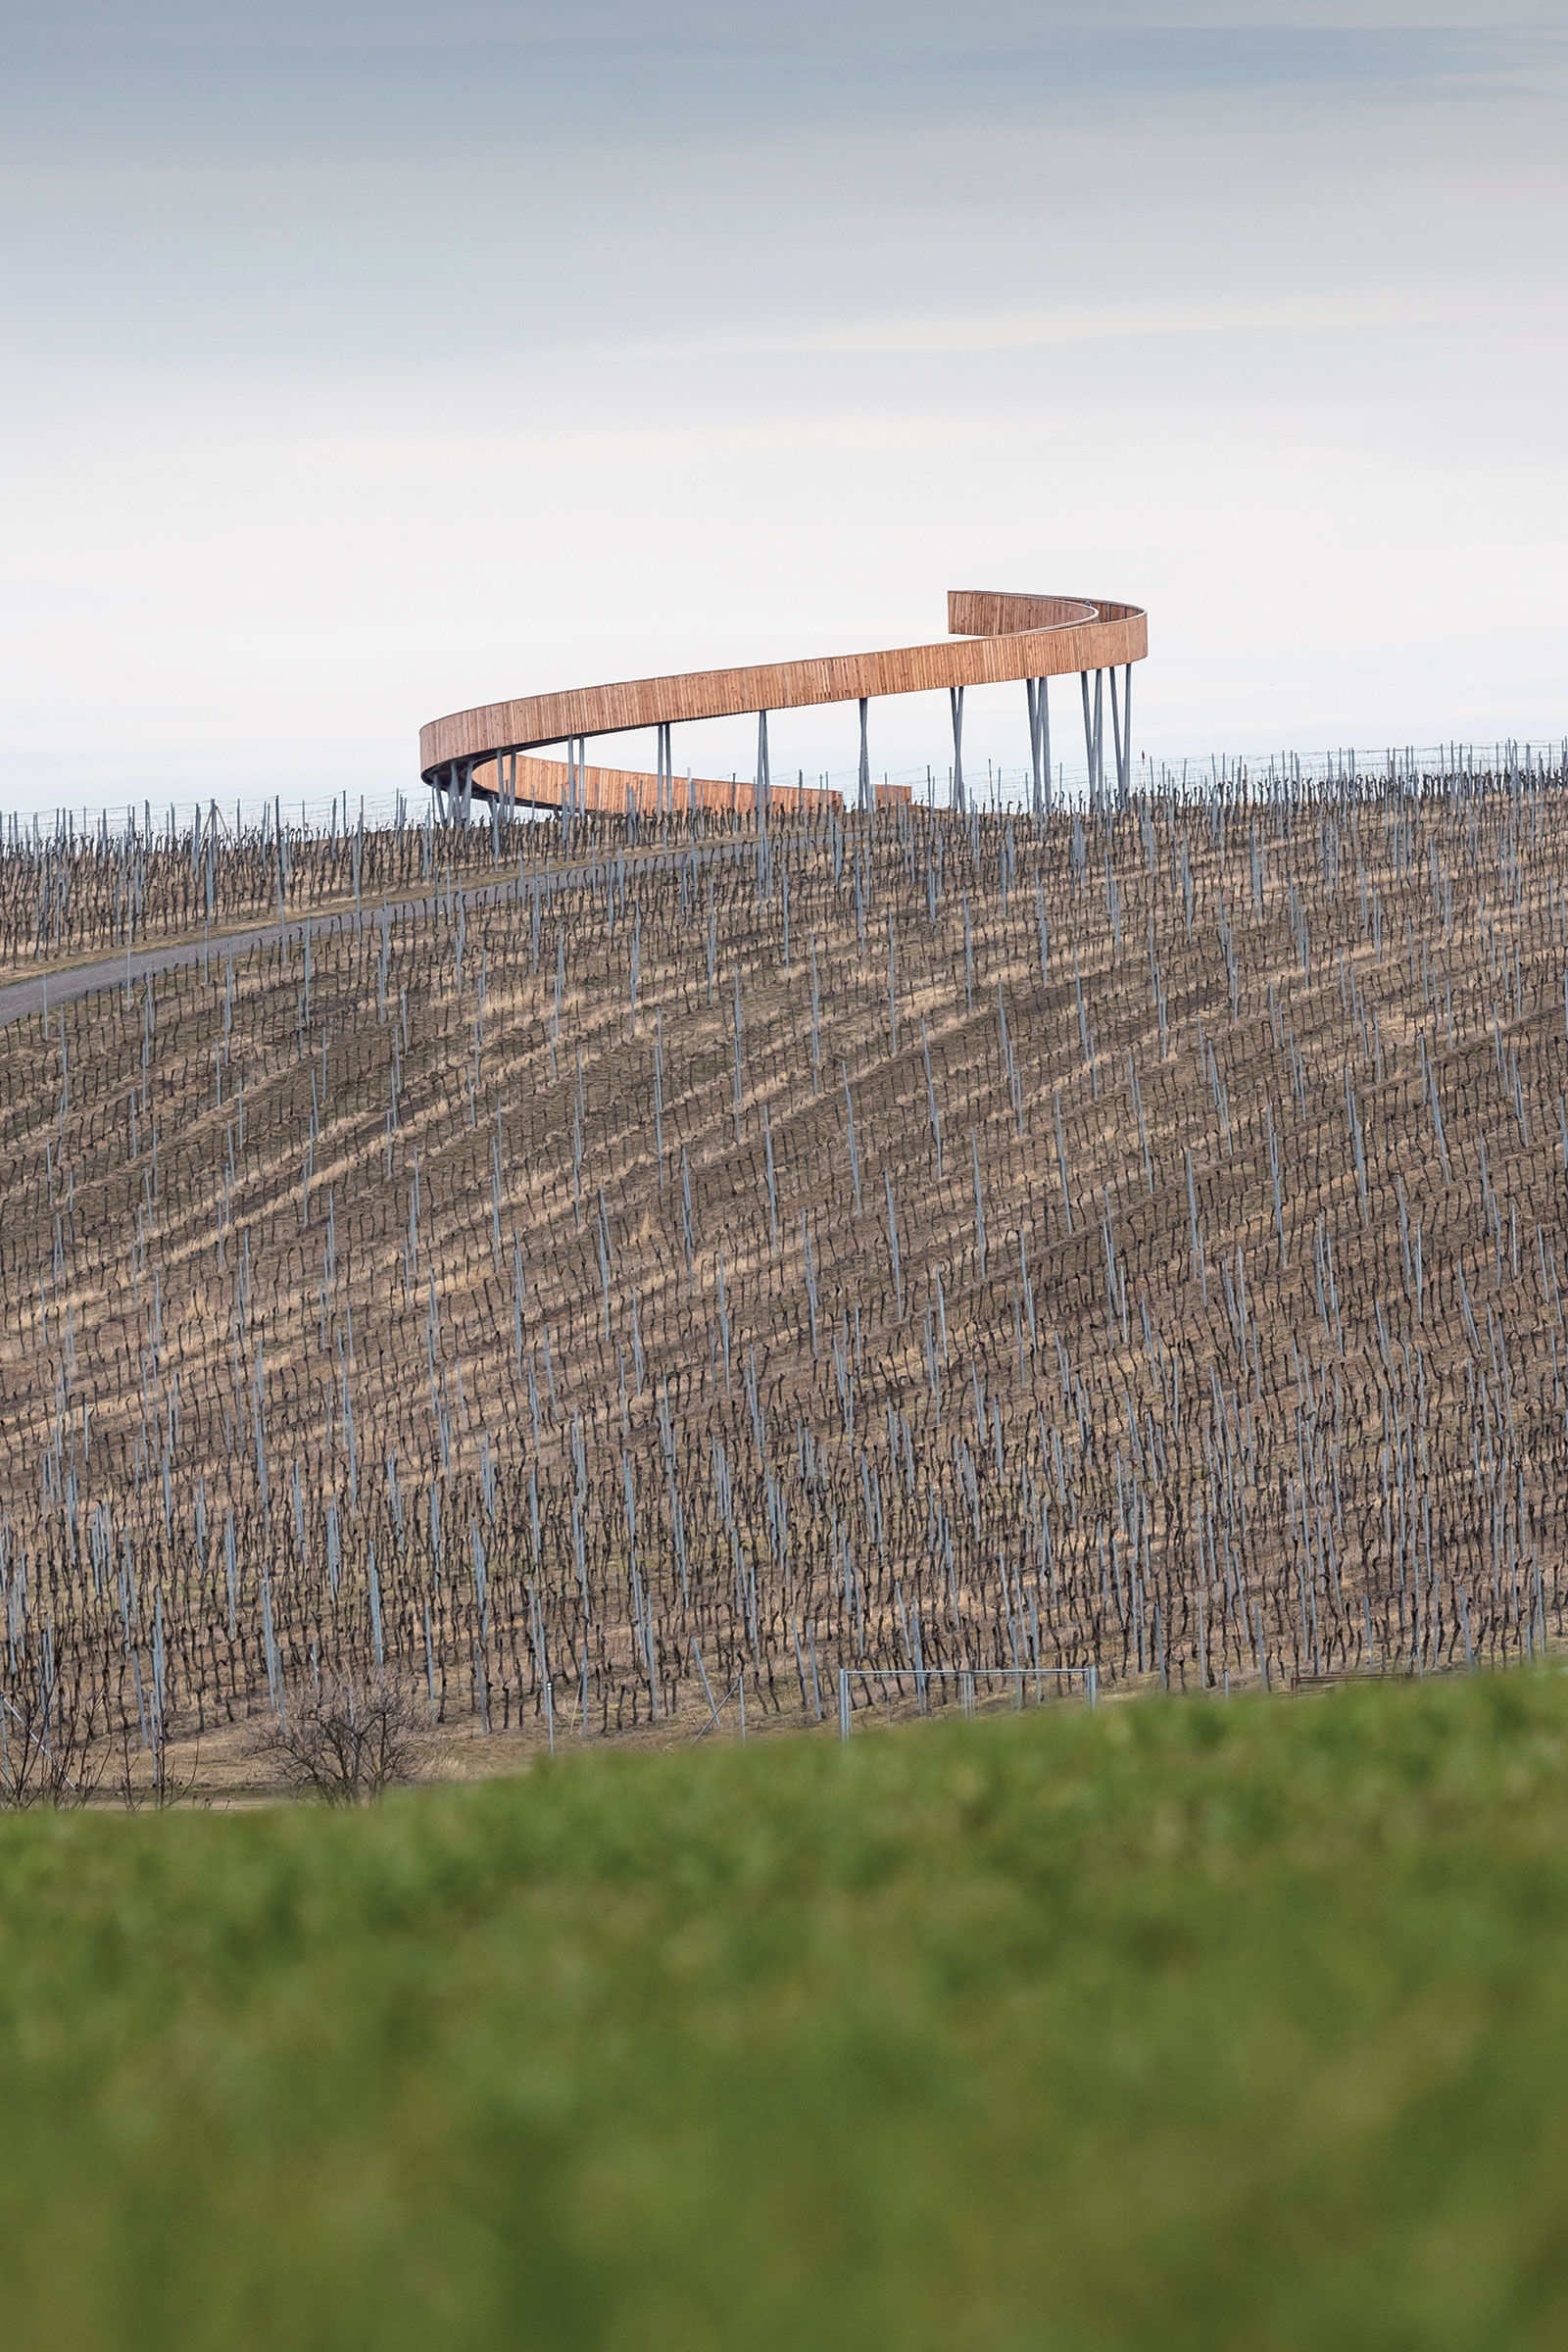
[418,588,1150,776]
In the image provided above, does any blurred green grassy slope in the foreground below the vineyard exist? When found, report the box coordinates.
[0,1675,1568,2352]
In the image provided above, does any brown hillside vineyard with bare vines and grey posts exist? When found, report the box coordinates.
[0,762,1568,1788]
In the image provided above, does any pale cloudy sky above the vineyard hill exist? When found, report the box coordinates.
[0,0,1568,809]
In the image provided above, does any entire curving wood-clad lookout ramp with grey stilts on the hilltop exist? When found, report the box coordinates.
[418,588,1150,816]
